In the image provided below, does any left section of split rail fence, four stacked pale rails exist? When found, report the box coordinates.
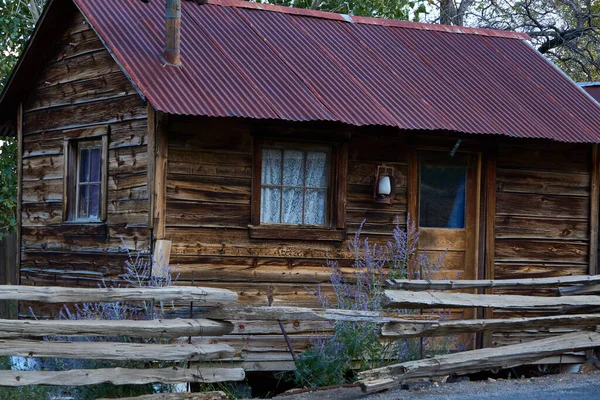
[0,285,244,386]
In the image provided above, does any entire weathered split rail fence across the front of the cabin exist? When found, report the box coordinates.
[0,276,600,392]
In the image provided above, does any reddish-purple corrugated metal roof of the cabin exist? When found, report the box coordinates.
[74,0,600,142]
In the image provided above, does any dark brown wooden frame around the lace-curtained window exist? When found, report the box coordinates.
[248,136,348,241]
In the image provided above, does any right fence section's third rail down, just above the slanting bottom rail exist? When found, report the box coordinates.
[381,314,600,337]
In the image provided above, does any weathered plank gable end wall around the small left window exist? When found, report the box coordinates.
[21,13,151,312]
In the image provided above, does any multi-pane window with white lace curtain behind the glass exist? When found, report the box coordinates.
[260,146,331,226]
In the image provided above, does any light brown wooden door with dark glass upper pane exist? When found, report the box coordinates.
[409,150,480,318]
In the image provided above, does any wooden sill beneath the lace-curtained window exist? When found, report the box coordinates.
[248,225,346,242]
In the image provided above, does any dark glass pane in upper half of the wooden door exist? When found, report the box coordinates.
[419,155,467,228]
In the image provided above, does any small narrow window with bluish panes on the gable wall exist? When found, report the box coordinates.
[63,136,107,222]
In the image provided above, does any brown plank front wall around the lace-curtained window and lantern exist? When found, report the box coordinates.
[165,116,407,368]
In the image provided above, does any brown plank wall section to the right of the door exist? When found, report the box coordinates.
[493,141,592,345]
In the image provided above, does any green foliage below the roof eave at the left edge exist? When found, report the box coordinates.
[0,138,17,240]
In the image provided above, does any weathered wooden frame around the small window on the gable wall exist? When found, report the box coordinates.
[63,127,108,224]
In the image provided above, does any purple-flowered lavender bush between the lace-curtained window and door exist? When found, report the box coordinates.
[294,216,452,387]
